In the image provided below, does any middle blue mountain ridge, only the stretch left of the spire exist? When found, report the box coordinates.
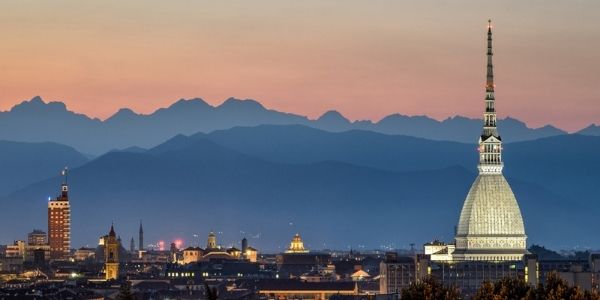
[199,125,476,171]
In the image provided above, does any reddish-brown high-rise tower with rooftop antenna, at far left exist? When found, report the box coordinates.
[48,168,71,259]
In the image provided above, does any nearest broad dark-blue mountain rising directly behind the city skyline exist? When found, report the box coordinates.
[0,126,600,251]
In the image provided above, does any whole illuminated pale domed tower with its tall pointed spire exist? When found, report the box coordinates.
[452,21,527,261]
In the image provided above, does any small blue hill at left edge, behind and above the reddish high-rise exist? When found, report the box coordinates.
[0,141,88,195]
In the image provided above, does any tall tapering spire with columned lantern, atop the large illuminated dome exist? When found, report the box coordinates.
[478,20,503,174]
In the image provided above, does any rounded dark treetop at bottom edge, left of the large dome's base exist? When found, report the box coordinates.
[400,276,461,300]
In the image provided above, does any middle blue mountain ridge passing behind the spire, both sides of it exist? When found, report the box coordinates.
[199,125,600,204]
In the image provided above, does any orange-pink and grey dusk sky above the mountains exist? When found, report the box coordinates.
[0,0,600,131]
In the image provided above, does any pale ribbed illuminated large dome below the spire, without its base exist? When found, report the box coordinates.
[456,174,525,237]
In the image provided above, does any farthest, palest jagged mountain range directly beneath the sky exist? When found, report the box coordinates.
[0,97,565,155]
